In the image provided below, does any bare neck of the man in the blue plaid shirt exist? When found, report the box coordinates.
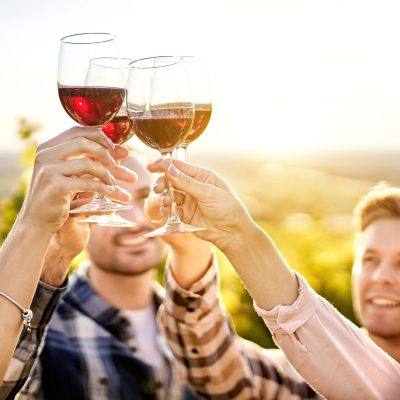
[89,265,154,310]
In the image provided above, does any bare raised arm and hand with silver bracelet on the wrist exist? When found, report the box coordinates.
[0,128,134,388]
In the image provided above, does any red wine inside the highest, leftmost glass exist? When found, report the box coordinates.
[58,86,125,126]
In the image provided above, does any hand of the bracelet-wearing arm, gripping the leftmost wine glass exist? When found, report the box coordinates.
[23,127,136,232]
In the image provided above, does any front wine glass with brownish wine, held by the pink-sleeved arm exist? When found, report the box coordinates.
[127,56,204,237]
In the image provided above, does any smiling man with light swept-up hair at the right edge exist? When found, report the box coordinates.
[353,187,400,362]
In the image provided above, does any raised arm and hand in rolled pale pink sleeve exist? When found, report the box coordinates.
[149,161,400,399]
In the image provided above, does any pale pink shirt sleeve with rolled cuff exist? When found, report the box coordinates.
[254,275,400,400]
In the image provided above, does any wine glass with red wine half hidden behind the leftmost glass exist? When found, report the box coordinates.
[81,57,136,227]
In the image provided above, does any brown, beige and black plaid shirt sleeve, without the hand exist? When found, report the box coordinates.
[158,262,322,400]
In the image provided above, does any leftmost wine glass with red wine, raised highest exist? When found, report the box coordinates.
[57,33,129,217]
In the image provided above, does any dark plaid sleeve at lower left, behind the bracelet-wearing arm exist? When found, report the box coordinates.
[0,282,66,400]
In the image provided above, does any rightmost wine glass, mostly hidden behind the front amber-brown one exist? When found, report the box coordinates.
[176,56,212,161]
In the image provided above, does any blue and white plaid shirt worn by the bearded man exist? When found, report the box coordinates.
[18,270,197,400]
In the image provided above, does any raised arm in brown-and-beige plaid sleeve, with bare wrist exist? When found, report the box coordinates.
[146,182,321,399]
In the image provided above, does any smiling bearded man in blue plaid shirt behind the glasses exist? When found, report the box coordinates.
[18,157,212,400]
